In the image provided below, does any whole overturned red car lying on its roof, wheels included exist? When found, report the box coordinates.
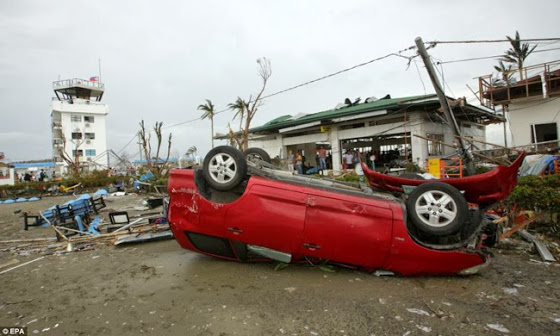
[167,146,512,275]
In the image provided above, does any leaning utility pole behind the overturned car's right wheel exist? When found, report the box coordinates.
[414,37,474,175]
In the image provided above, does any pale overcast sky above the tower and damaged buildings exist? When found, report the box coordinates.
[0,0,560,161]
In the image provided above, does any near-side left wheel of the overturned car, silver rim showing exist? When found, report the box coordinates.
[202,146,247,191]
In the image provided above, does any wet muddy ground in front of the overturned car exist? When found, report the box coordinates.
[0,195,560,335]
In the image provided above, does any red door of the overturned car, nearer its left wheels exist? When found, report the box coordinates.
[225,182,307,254]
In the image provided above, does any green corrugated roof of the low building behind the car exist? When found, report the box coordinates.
[249,94,437,133]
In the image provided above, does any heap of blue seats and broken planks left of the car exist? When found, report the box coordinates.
[0,194,173,256]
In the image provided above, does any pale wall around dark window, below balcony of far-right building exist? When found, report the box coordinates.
[507,98,560,146]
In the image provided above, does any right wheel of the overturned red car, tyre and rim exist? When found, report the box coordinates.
[407,182,468,236]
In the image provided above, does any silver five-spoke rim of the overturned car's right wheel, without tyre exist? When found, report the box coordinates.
[414,190,457,228]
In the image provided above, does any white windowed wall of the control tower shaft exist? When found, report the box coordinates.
[51,99,109,173]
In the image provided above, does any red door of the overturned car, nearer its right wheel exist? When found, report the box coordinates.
[299,194,393,267]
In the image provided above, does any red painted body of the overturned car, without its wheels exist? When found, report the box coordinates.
[167,169,488,275]
